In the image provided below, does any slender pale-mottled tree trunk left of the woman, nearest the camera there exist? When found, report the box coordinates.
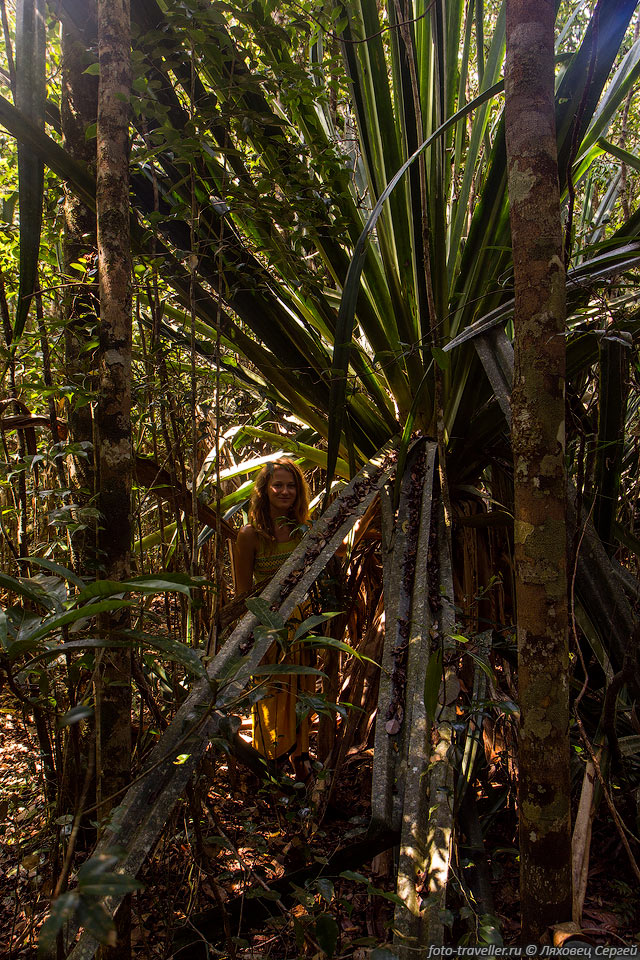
[96,0,133,960]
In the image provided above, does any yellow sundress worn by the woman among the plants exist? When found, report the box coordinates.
[251,537,316,760]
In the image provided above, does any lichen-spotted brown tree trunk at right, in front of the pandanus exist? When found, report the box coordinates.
[505,0,571,942]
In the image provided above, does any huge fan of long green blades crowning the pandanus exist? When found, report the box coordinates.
[3,0,639,482]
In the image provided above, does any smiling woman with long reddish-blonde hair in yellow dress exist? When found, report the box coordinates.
[234,457,315,780]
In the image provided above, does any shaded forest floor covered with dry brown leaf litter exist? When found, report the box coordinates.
[0,693,640,960]
